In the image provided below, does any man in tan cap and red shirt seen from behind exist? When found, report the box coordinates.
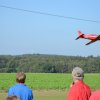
[67,67,91,100]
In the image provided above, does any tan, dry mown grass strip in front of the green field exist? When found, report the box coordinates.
[0,90,66,100]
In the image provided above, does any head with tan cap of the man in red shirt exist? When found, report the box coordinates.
[72,67,84,81]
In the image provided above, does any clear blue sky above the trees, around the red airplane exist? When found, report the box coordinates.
[0,0,100,56]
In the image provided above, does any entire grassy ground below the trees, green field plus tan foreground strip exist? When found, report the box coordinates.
[0,73,100,100]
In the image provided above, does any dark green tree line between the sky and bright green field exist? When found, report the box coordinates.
[0,54,100,73]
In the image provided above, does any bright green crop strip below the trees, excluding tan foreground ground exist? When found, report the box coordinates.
[0,73,100,91]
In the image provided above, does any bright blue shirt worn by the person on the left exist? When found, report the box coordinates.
[8,84,33,100]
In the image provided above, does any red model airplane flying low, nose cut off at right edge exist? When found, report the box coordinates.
[76,31,100,45]
